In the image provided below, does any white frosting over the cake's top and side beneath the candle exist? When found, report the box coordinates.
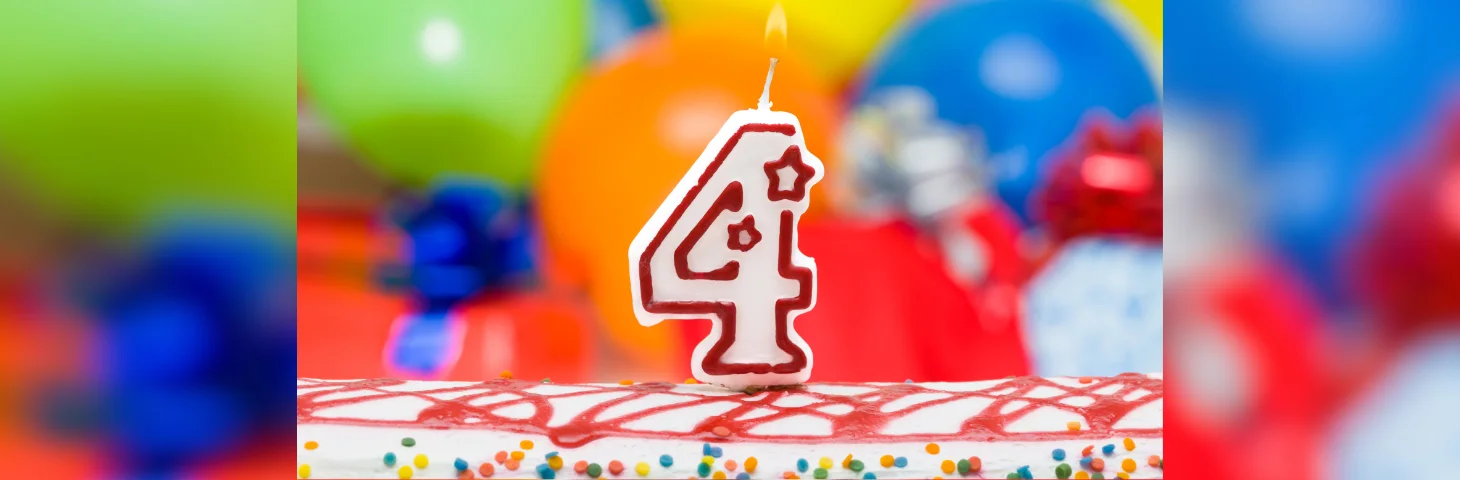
[296,378,1164,479]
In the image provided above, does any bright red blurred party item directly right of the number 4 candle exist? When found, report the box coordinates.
[682,220,1029,382]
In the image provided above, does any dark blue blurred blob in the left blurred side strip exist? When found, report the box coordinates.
[67,214,295,479]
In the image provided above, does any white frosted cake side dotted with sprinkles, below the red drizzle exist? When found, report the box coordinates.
[296,425,1164,480]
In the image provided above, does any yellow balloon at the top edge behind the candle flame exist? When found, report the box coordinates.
[660,0,911,86]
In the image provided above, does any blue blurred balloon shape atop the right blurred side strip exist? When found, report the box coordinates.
[1165,0,1460,308]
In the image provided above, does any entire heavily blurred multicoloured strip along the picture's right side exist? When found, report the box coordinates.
[1164,0,1460,479]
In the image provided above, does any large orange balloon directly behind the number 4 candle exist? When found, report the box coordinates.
[539,32,841,370]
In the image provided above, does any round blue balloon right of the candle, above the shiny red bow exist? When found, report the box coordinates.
[860,0,1158,220]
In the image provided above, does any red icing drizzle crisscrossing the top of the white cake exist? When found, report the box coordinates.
[296,373,1164,448]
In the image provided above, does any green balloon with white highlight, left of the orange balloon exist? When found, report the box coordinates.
[299,0,587,187]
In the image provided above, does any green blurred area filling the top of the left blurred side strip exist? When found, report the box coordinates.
[0,0,296,229]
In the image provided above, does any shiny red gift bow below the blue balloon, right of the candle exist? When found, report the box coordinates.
[1031,115,1162,241]
